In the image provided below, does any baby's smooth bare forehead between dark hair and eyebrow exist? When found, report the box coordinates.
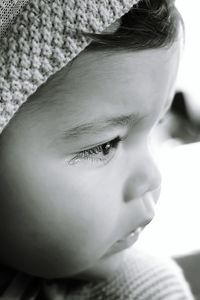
[14,43,179,141]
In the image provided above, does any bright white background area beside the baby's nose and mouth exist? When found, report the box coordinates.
[137,143,200,256]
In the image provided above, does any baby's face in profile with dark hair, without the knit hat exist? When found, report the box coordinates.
[0,0,183,278]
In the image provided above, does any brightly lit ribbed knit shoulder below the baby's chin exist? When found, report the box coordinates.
[116,249,194,300]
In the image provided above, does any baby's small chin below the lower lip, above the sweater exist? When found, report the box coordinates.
[74,251,124,281]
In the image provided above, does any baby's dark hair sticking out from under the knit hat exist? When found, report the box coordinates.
[83,0,183,51]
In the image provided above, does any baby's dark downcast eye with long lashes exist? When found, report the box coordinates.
[68,137,122,165]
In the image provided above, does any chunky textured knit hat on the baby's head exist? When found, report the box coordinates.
[0,0,140,133]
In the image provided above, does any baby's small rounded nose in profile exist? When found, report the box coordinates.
[123,149,161,202]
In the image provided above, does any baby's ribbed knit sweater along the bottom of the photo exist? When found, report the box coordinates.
[0,249,194,300]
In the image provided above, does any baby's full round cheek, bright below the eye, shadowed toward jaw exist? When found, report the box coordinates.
[2,157,120,276]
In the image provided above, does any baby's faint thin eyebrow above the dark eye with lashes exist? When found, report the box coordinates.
[62,114,141,139]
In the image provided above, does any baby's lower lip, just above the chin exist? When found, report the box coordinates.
[105,227,142,256]
